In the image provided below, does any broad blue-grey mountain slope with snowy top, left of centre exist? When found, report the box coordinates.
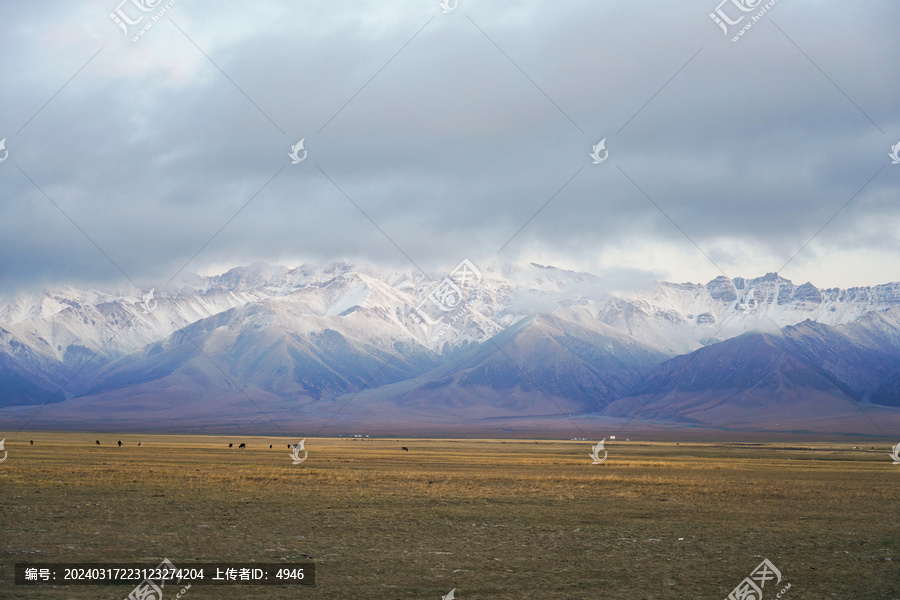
[75,276,442,401]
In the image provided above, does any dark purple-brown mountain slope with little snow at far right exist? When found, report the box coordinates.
[604,323,898,430]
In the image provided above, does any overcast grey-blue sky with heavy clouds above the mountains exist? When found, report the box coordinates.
[0,0,900,295]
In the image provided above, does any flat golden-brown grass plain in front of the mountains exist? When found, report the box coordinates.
[0,432,900,600]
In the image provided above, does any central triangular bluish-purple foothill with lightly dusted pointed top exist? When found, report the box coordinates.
[334,314,667,421]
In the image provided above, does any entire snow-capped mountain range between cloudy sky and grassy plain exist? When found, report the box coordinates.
[0,261,900,430]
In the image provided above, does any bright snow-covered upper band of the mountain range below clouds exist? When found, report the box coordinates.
[0,260,900,384]
